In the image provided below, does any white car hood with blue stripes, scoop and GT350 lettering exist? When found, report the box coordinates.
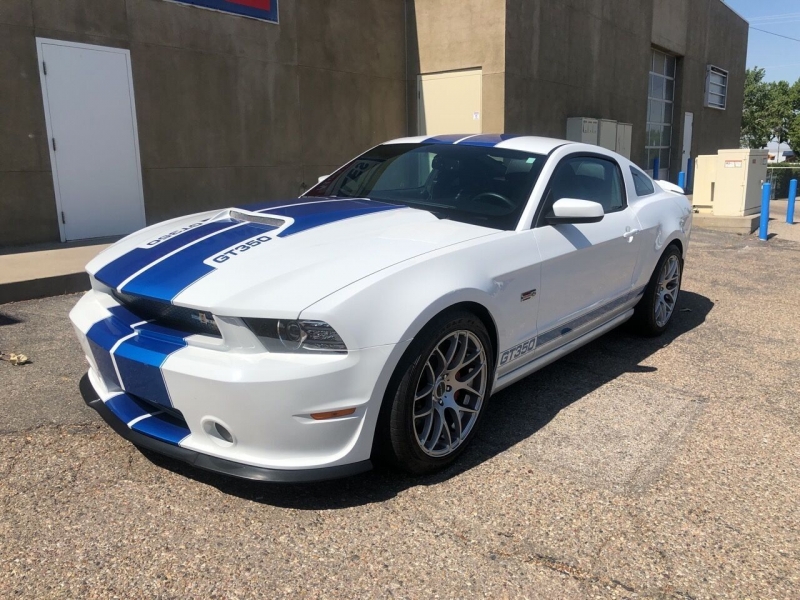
[87,198,497,318]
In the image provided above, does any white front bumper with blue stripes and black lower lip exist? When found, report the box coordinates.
[70,290,401,481]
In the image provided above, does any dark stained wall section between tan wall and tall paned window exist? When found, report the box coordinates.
[506,0,653,166]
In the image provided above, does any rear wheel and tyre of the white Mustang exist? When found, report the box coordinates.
[634,245,683,336]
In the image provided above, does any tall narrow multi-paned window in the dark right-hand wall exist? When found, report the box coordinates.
[645,50,676,172]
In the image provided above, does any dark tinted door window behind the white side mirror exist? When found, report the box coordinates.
[542,156,626,223]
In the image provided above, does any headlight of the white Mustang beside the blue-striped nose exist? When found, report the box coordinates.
[244,319,347,354]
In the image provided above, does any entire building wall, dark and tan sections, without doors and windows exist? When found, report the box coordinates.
[0,0,748,246]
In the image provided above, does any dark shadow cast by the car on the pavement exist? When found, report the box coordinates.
[141,291,714,510]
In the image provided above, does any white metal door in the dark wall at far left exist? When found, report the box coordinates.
[37,38,145,241]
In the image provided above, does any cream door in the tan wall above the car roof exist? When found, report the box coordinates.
[417,69,483,136]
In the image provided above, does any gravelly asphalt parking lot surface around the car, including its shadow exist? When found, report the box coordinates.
[0,226,800,599]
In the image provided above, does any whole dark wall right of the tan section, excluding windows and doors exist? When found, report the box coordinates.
[505,0,748,180]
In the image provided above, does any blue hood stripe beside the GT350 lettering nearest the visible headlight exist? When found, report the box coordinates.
[122,223,276,302]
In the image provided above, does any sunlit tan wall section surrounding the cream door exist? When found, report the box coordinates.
[406,0,506,135]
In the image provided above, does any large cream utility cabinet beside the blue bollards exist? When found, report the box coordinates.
[692,150,767,217]
